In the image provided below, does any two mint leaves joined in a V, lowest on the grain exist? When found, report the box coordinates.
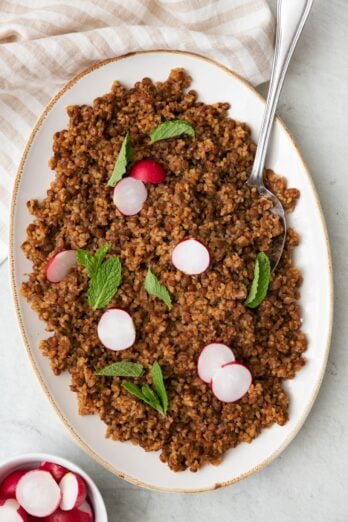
[122,361,168,415]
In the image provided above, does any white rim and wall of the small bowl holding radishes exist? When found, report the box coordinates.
[0,453,108,522]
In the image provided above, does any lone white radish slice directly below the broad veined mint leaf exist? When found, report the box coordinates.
[98,308,135,351]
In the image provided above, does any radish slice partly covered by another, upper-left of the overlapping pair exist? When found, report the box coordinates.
[197,343,235,383]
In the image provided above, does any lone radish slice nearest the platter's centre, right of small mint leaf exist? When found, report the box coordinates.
[172,239,210,275]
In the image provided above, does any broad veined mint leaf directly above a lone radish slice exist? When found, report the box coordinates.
[87,257,122,310]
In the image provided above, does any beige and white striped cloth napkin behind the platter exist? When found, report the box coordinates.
[0,0,274,262]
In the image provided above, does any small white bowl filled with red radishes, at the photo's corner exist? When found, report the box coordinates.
[0,453,108,522]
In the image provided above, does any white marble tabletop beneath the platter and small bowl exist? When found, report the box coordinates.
[0,0,348,522]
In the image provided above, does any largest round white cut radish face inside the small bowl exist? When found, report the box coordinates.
[16,469,62,517]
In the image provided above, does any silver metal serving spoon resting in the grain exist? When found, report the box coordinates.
[247,0,313,270]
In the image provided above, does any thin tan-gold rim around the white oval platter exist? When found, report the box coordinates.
[9,49,333,493]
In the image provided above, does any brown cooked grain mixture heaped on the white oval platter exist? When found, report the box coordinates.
[22,69,307,471]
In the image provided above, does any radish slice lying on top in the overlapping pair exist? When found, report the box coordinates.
[211,362,252,402]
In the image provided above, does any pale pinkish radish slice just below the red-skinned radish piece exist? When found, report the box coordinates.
[113,178,147,216]
